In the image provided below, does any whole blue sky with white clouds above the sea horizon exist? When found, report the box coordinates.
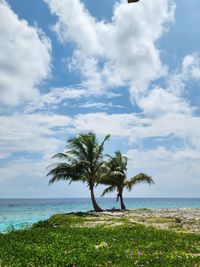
[0,0,200,198]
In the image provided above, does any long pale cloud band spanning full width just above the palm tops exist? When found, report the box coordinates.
[0,112,200,162]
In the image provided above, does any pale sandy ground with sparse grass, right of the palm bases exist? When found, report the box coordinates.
[74,208,200,233]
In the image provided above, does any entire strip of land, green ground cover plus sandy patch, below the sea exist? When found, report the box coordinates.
[0,208,200,267]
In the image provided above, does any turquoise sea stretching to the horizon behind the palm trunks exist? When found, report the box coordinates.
[0,198,200,232]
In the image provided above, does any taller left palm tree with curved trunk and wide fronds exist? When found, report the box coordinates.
[47,133,110,211]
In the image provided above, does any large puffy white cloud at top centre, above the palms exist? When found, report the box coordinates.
[45,0,175,97]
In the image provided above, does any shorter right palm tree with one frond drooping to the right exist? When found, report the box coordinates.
[99,151,154,210]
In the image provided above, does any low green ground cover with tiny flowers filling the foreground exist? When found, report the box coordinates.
[0,215,200,267]
